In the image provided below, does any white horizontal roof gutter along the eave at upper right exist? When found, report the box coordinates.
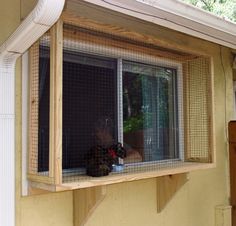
[81,0,236,49]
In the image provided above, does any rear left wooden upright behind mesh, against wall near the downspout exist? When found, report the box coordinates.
[28,42,39,174]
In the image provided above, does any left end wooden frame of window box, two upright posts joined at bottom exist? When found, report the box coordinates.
[28,20,63,184]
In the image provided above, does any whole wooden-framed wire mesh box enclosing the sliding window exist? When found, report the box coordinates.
[28,21,214,190]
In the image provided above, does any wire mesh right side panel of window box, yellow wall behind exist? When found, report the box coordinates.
[184,57,212,162]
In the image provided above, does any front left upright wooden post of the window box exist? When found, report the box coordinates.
[49,20,63,184]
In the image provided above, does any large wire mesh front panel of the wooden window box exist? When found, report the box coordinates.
[59,24,212,183]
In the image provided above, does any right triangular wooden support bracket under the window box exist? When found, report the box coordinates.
[156,173,188,213]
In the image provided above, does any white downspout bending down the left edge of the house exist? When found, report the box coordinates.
[0,0,65,226]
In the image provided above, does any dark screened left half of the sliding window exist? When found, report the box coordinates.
[63,51,117,169]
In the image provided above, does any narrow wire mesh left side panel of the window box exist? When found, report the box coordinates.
[29,34,50,176]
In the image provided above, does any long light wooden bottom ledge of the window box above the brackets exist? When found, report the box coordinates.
[30,161,215,192]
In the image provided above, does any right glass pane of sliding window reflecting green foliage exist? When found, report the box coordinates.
[122,61,178,162]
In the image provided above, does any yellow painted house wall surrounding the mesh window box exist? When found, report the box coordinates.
[0,0,233,226]
